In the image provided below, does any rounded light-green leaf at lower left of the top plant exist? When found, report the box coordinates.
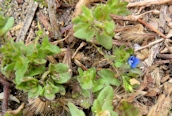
[74,27,96,41]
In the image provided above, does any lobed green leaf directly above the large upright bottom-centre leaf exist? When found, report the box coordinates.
[98,69,120,86]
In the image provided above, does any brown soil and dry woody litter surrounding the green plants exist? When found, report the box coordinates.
[0,0,172,116]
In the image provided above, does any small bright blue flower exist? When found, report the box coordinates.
[128,56,140,68]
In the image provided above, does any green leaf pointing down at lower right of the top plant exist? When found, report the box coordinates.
[96,32,112,50]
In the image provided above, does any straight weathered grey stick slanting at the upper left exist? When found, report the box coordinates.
[16,0,38,41]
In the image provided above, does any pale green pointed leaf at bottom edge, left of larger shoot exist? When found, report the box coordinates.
[68,102,85,116]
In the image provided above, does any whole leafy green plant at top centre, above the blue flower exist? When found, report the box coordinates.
[72,0,128,49]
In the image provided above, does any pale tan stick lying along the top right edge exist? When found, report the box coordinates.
[127,0,172,8]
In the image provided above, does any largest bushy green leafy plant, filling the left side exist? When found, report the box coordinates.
[0,37,70,100]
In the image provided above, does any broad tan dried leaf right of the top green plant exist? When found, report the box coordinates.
[121,24,154,43]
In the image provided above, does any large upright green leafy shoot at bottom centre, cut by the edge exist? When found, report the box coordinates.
[91,86,117,116]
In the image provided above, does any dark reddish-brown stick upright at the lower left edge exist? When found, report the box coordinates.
[0,74,10,115]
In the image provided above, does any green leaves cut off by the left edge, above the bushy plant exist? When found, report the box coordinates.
[0,15,14,37]
